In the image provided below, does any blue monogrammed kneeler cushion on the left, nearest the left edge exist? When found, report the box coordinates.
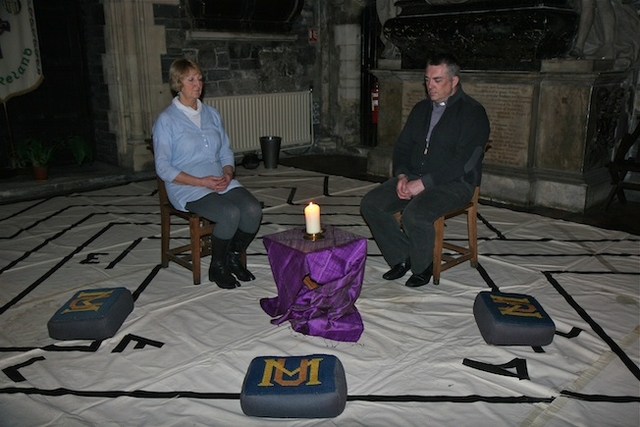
[47,288,133,340]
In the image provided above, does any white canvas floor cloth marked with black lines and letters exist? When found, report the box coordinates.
[0,166,640,427]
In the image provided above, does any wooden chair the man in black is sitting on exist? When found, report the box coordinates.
[433,186,480,285]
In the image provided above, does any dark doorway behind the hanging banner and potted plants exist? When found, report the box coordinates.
[0,0,95,167]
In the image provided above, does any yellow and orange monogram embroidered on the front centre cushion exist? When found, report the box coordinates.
[258,358,322,387]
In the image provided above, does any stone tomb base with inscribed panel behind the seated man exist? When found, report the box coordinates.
[368,60,633,212]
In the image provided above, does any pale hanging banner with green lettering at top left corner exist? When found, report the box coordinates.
[0,0,43,103]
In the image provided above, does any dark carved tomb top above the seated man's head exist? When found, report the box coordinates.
[383,0,579,71]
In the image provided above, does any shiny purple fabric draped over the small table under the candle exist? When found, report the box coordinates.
[260,226,367,342]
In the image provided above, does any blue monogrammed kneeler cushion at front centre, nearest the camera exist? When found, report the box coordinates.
[240,354,347,418]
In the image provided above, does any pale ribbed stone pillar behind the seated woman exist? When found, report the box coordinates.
[103,0,171,171]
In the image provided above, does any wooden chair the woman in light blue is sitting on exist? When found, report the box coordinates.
[156,177,215,285]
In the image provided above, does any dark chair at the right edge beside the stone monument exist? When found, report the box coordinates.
[604,122,640,210]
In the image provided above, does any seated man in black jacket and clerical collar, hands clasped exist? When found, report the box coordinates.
[360,54,489,287]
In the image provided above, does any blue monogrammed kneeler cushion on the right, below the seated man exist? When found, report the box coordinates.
[473,291,556,347]
